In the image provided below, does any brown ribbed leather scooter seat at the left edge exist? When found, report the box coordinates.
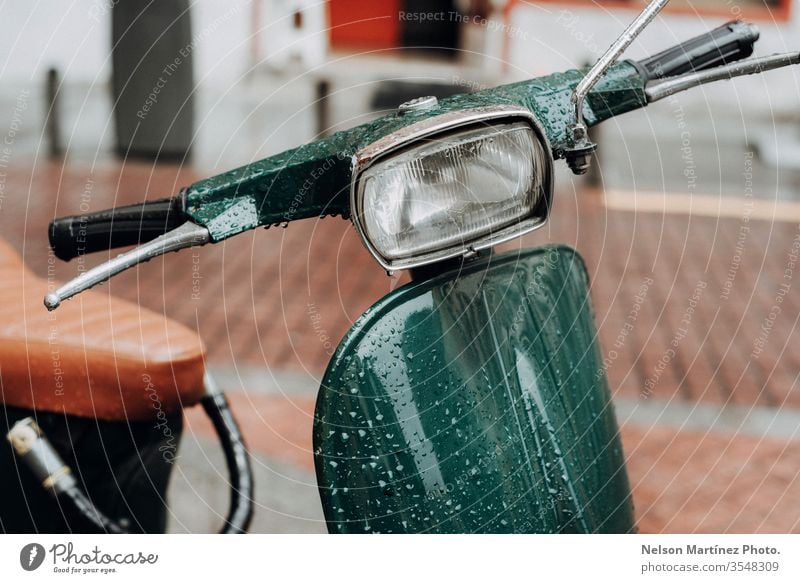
[0,240,204,421]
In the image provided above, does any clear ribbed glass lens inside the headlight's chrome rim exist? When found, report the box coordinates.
[357,122,549,261]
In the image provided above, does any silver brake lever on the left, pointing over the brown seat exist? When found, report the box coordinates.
[44,221,211,312]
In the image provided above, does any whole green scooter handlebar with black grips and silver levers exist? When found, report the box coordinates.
[44,17,800,310]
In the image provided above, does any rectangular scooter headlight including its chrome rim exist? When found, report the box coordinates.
[351,107,553,270]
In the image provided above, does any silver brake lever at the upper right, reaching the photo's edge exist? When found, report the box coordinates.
[644,53,800,103]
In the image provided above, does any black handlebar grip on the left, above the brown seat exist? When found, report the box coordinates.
[49,196,186,261]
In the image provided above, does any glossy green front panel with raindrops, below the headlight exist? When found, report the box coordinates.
[314,246,634,533]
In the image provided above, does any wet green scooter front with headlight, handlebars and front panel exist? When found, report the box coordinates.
[45,0,800,533]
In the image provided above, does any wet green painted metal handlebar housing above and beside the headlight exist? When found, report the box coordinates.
[181,62,647,242]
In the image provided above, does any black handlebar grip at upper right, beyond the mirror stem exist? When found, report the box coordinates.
[636,20,760,81]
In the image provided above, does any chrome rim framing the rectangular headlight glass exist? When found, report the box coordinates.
[350,105,555,272]
